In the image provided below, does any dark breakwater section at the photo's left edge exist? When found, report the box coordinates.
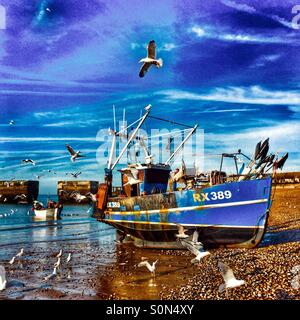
[0,180,39,204]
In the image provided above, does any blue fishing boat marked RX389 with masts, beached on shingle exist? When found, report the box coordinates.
[95,107,284,248]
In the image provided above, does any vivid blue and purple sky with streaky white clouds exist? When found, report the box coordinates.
[0,0,300,192]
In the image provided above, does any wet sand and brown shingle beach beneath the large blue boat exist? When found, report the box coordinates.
[0,188,300,300]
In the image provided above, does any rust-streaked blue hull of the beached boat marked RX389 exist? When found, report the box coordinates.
[100,178,272,248]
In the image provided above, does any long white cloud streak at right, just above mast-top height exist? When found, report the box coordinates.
[156,86,300,105]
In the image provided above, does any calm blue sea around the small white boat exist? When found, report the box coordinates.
[0,195,116,260]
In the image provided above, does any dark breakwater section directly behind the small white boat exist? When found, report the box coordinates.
[57,180,99,204]
